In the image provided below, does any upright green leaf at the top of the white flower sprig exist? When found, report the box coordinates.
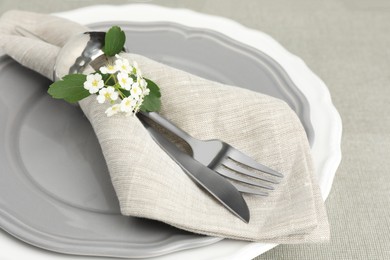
[103,26,126,57]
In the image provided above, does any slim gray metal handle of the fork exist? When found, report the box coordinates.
[139,111,197,148]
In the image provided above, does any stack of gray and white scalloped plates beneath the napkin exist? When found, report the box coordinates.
[0,5,341,259]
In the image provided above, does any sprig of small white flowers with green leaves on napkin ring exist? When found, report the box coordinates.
[48,26,161,117]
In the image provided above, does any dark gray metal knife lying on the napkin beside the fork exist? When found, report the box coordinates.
[139,117,250,223]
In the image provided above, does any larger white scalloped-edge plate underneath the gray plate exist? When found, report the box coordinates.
[0,5,341,259]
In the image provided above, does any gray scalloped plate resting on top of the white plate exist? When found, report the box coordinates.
[0,22,314,258]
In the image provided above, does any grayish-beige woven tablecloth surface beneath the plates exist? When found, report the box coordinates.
[0,0,390,260]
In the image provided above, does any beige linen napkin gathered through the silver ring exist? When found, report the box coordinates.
[0,11,329,243]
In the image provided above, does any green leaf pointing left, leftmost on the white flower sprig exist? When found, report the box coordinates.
[47,74,90,103]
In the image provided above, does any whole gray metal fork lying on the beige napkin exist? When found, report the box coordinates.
[138,112,283,196]
